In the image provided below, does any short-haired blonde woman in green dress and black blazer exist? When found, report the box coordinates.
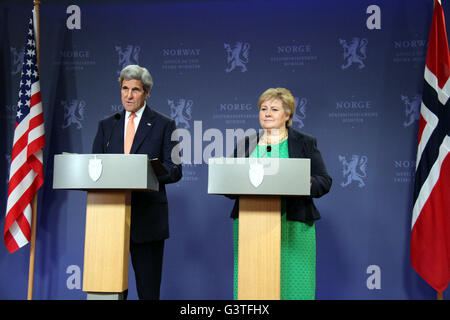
[231,88,332,300]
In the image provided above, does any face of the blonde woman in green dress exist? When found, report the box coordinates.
[259,99,289,130]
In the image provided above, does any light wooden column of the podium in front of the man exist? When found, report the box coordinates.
[83,190,131,292]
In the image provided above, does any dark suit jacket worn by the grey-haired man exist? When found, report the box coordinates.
[92,105,182,243]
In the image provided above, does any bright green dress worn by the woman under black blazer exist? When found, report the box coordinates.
[233,140,316,300]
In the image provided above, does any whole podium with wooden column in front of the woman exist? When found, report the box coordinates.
[208,158,311,300]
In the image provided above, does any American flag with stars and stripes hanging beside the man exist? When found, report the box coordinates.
[4,11,45,253]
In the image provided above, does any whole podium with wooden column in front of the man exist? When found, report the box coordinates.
[53,154,159,299]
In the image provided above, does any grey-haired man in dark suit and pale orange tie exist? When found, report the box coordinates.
[92,65,182,300]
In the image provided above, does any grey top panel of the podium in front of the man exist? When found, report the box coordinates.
[53,154,159,191]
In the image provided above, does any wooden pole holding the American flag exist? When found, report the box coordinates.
[27,0,40,300]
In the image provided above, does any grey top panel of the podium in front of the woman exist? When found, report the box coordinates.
[208,158,311,196]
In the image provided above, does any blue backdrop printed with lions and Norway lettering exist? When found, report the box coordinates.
[0,0,450,299]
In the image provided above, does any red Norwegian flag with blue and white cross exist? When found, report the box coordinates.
[411,0,450,292]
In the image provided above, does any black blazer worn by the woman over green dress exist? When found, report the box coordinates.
[231,128,332,223]
